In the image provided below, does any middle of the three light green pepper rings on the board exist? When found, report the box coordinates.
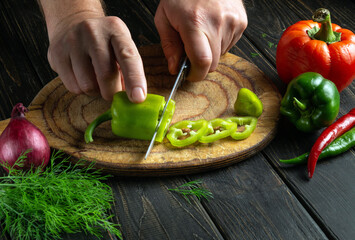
[199,118,237,143]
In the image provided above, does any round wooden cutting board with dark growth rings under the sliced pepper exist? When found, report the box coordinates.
[0,46,281,176]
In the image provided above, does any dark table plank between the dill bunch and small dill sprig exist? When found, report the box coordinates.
[110,177,222,239]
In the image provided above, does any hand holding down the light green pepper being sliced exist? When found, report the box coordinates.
[48,12,147,103]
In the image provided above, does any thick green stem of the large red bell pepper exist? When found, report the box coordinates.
[310,8,341,44]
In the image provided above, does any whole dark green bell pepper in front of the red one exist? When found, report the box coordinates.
[280,72,340,132]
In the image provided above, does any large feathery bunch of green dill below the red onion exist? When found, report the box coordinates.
[0,151,121,240]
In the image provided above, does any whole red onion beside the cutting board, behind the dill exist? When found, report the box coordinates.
[0,103,50,171]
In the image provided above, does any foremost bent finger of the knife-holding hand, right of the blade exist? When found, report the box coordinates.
[181,30,212,81]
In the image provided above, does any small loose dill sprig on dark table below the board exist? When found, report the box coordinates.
[168,180,213,202]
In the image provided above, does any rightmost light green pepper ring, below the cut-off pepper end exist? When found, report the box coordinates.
[226,117,258,140]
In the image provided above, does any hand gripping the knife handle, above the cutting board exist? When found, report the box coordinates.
[155,0,248,81]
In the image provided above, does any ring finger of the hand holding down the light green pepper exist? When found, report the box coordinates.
[71,50,99,96]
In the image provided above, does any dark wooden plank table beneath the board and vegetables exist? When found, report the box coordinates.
[0,0,355,239]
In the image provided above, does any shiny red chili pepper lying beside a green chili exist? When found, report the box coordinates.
[308,108,355,178]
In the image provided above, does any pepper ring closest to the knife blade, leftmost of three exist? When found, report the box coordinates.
[166,119,208,147]
